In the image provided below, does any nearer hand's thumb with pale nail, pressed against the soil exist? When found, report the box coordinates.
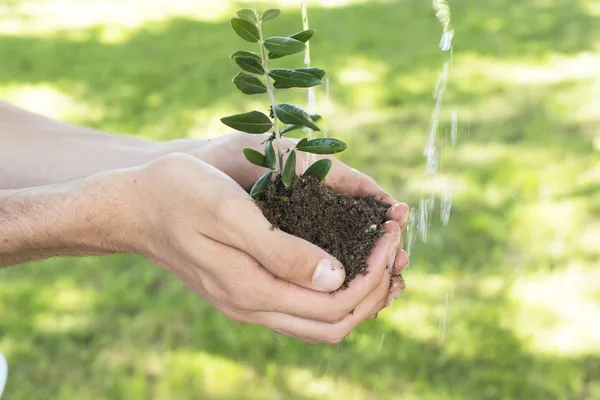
[218,197,346,292]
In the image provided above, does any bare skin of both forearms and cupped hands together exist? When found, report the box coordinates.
[0,103,408,343]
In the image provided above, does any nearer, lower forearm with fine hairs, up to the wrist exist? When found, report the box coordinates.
[0,170,131,267]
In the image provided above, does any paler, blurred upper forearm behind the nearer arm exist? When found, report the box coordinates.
[0,102,168,190]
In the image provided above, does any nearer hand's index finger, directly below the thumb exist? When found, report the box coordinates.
[195,230,395,323]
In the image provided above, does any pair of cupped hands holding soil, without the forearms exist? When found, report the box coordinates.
[109,134,409,343]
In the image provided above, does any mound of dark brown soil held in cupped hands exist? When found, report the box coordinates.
[257,176,389,288]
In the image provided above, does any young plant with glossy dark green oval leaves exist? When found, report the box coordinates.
[221,9,347,199]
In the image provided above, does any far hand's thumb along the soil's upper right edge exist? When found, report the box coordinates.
[324,158,398,206]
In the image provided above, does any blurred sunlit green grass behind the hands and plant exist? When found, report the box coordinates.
[0,0,600,400]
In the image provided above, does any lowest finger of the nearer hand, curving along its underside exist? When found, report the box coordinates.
[255,264,389,344]
